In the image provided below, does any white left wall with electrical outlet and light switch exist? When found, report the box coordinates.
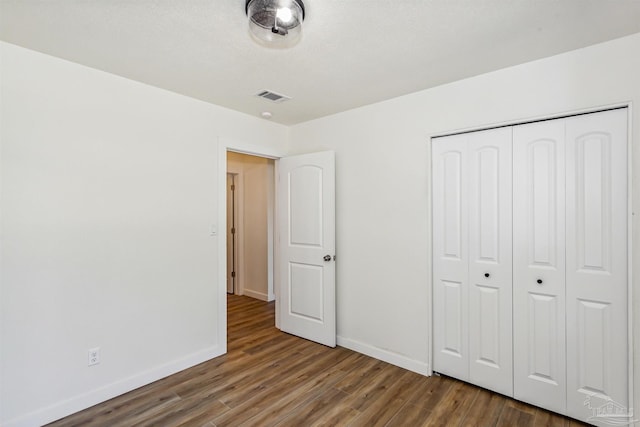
[0,43,287,426]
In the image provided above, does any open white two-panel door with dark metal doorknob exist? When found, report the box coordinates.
[277,151,336,347]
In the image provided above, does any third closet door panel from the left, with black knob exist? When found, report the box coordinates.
[513,120,566,413]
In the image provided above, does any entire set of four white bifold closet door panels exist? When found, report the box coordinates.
[432,108,630,425]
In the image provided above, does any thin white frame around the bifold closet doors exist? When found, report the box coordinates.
[426,101,640,418]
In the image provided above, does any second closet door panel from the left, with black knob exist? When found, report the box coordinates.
[468,128,513,396]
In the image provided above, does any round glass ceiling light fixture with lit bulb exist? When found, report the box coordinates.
[245,0,304,47]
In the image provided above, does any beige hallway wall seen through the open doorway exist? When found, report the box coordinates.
[227,152,275,301]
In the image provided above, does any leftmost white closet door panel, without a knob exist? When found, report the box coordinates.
[432,135,469,380]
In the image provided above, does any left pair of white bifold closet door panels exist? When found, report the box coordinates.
[432,128,513,395]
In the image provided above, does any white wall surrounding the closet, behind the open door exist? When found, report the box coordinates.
[290,34,640,384]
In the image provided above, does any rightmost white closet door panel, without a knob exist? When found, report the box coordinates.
[566,109,629,421]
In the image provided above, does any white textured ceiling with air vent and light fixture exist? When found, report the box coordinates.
[0,0,640,125]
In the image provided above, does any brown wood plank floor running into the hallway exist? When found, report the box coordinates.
[50,296,581,427]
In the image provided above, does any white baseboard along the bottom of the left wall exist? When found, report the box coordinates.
[3,346,224,427]
